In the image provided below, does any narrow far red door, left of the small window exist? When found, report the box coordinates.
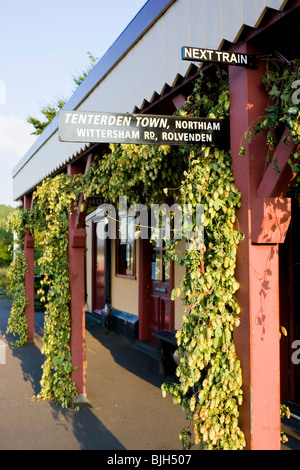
[92,217,105,313]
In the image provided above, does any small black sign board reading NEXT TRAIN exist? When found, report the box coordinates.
[181,46,258,68]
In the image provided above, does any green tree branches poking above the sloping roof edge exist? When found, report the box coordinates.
[27,52,98,135]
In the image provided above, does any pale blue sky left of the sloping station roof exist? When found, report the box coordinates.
[0,0,147,206]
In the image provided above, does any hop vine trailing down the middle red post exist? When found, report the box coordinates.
[29,174,82,407]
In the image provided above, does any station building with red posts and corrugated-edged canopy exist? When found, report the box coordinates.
[13,0,300,450]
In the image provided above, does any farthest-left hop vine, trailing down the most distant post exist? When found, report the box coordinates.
[6,209,28,347]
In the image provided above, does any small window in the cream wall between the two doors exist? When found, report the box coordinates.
[116,214,136,278]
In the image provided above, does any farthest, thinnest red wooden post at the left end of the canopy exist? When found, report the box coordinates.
[23,195,35,343]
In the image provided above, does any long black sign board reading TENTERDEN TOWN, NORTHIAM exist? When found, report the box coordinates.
[58,111,225,146]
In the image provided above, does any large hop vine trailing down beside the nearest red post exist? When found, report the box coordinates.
[162,69,245,450]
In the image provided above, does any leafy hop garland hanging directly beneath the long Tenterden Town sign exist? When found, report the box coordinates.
[85,144,185,204]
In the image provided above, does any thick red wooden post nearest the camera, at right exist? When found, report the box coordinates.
[229,45,280,450]
